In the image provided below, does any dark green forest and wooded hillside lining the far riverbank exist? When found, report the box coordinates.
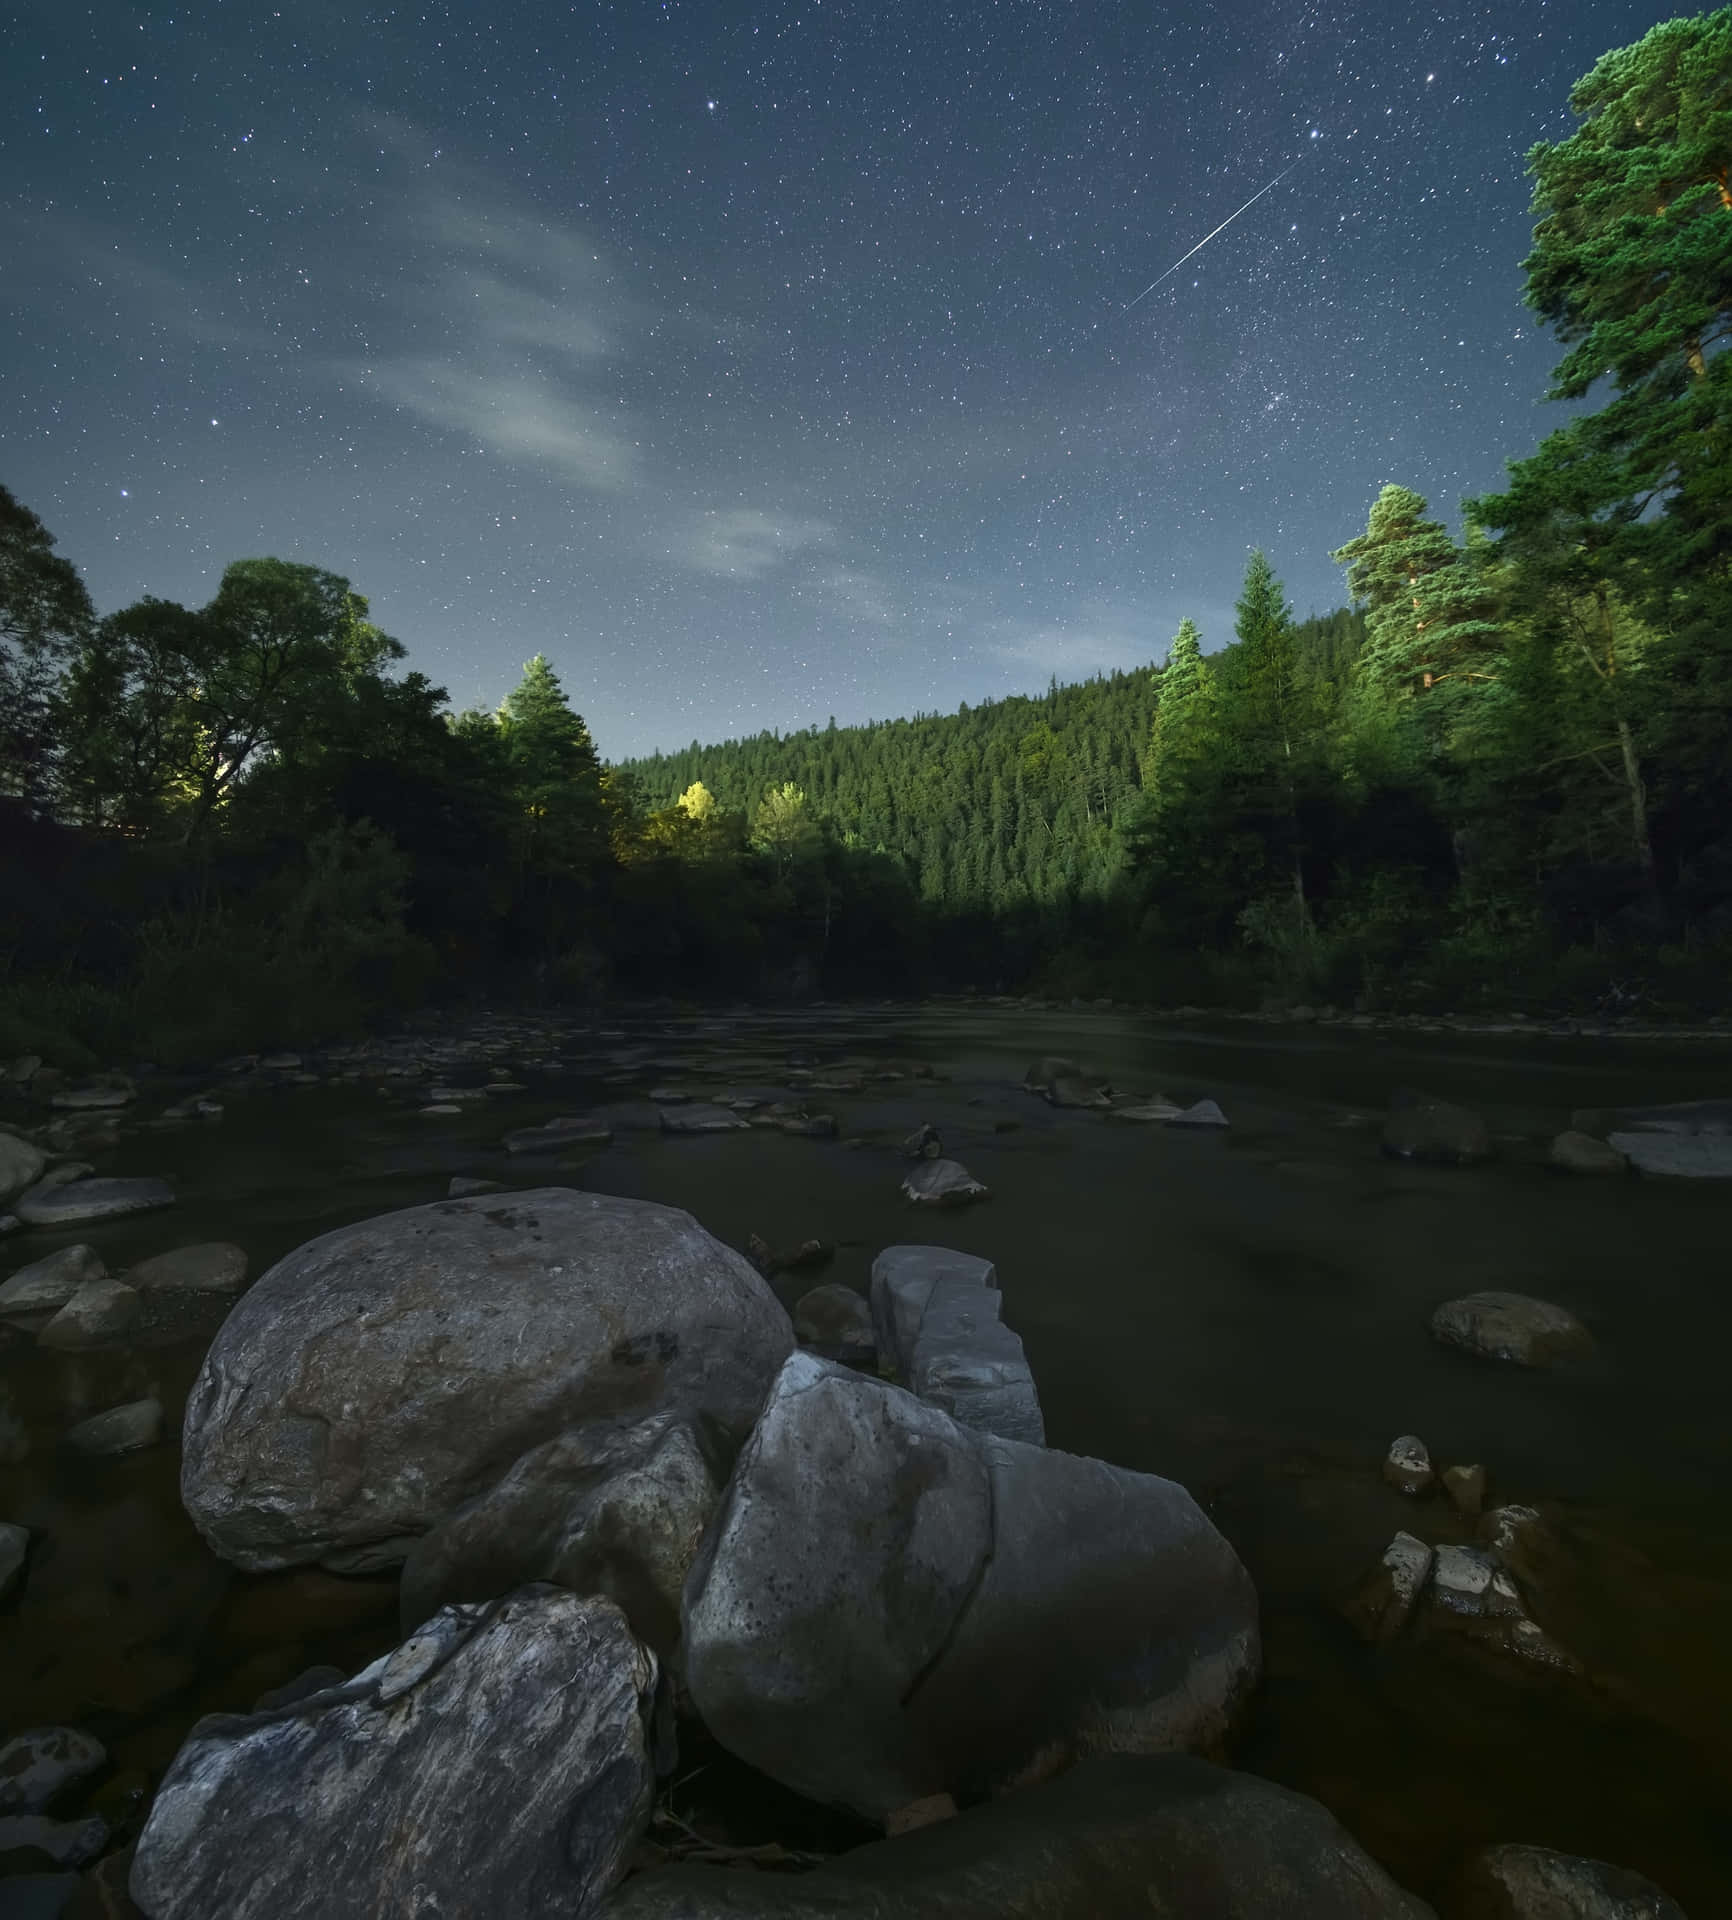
[0,8,1732,1060]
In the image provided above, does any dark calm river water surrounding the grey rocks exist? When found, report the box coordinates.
[0,1006,1732,1916]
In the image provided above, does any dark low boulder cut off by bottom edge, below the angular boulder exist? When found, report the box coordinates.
[601,1753,1436,1920]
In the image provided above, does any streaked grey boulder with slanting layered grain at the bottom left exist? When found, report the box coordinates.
[131,1586,657,1920]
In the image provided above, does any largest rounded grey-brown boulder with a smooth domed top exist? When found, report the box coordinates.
[180,1187,793,1572]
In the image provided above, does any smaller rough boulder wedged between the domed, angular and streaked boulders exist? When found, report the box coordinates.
[401,1413,720,1653]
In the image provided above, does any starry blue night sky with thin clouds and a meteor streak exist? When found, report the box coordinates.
[0,0,1678,758]
